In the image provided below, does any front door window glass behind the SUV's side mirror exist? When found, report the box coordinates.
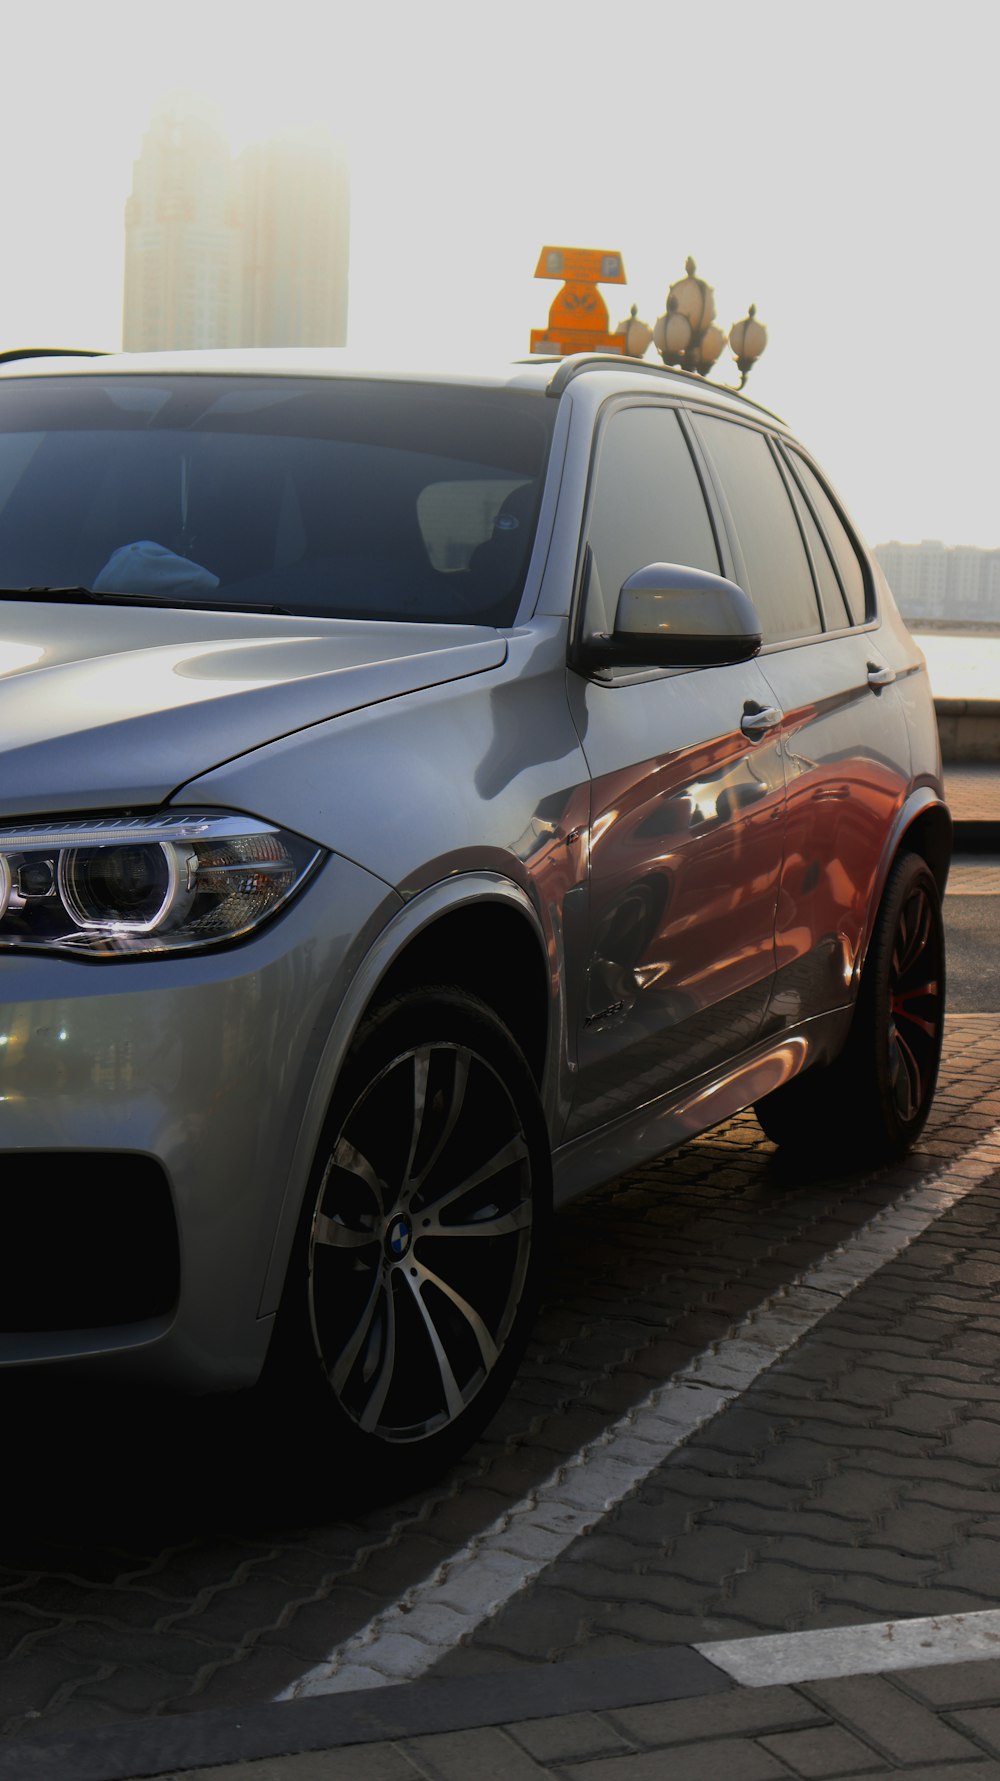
[585,408,718,630]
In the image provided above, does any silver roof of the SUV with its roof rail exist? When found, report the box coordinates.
[0,347,784,426]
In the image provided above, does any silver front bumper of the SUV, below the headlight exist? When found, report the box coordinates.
[0,858,399,1386]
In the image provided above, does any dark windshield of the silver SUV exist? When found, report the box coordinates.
[0,374,556,625]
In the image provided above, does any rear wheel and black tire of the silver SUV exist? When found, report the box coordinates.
[754,853,945,1165]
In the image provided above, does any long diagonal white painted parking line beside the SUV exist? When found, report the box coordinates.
[278,1126,1000,1701]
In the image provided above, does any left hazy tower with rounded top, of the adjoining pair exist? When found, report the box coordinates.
[123,100,242,353]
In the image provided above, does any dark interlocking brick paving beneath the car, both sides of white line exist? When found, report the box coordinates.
[0,891,1000,1776]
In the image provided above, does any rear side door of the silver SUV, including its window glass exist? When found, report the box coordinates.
[697,415,909,1031]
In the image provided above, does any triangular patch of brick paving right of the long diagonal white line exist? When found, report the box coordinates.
[424,1118,1000,1674]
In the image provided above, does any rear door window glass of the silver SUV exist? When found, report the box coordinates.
[697,415,822,643]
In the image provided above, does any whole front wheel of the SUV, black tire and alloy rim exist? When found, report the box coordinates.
[267,988,551,1494]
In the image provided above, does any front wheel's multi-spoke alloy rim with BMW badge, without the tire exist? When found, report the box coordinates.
[308,1040,533,1443]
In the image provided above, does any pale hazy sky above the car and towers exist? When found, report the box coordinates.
[0,0,1000,547]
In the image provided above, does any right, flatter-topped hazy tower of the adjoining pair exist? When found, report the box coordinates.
[239,139,349,346]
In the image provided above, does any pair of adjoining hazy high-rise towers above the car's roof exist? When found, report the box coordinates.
[123,98,349,353]
